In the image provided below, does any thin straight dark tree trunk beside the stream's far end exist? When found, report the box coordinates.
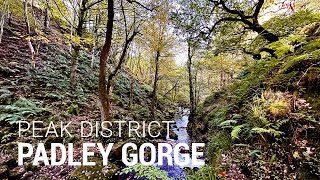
[187,42,195,121]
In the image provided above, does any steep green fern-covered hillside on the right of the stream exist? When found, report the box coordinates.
[190,20,320,179]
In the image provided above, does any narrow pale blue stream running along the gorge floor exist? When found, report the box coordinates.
[156,108,204,180]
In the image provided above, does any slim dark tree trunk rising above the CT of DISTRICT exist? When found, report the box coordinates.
[151,51,160,120]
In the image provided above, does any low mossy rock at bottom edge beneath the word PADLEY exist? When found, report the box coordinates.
[69,158,119,180]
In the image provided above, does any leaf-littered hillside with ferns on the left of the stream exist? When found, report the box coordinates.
[0,14,175,179]
